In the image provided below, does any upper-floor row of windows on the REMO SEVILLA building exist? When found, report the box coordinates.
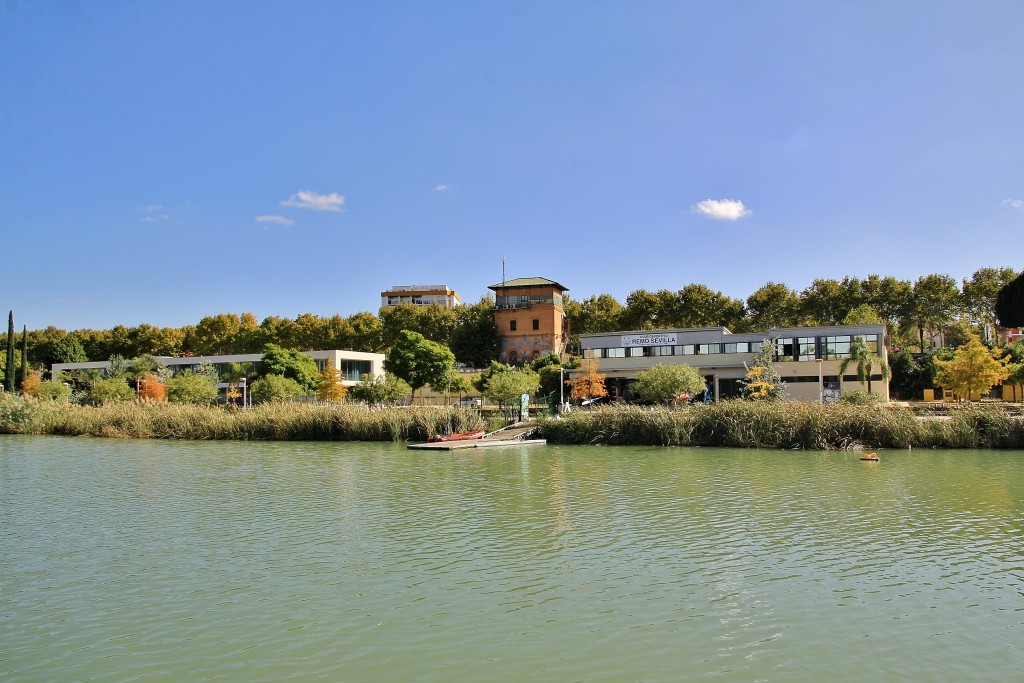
[585,333,882,361]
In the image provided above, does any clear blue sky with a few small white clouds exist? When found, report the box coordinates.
[0,0,1024,329]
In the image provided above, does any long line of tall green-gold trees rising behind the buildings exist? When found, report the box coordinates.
[0,267,1020,376]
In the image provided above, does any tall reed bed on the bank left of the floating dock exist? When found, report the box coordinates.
[0,396,484,441]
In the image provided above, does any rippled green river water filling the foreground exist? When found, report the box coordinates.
[0,436,1024,683]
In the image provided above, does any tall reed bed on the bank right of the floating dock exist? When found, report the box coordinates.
[540,400,1024,451]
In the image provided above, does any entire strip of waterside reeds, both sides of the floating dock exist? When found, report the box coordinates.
[0,396,1024,451]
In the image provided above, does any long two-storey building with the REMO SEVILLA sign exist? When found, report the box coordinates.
[580,325,889,400]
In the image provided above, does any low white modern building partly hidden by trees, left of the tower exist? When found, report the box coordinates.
[52,349,384,386]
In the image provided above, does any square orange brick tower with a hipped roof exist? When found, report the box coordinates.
[487,278,568,365]
